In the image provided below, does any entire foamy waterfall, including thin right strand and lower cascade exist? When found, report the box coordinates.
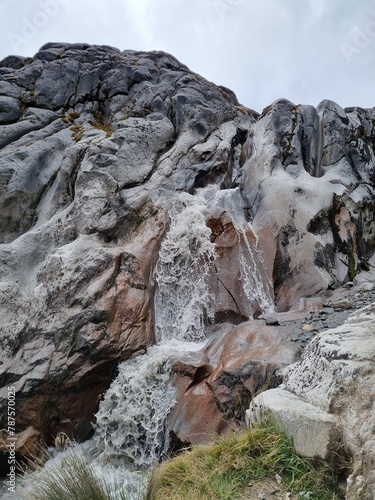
[16,187,273,498]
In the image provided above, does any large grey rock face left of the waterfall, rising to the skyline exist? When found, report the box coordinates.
[0,44,256,442]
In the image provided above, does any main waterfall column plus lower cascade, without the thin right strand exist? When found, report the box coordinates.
[95,193,219,469]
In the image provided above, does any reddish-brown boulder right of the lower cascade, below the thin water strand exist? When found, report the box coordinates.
[168,320,300,446]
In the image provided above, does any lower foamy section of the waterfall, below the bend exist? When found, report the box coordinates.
[95,346,175,469]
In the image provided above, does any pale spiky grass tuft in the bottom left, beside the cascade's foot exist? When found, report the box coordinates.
[19,447,126,500]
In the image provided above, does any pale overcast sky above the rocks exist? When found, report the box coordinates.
[0,0,375,111]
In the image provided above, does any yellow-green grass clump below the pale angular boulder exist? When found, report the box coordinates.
[147,425,339,500]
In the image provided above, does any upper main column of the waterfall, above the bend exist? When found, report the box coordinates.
[155,193,216,342]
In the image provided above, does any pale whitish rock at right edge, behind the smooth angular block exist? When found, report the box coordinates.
[285,304,375,499]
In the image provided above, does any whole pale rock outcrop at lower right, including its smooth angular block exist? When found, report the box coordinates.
[246,296,375,500]
